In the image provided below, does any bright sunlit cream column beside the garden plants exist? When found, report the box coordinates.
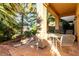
[37,3,47,39]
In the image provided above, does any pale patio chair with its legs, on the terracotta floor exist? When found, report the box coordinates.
[57,34,75,51]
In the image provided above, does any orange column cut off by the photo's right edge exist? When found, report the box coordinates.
[75,4,79,44]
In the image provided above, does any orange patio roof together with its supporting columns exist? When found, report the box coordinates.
[37,3,79,42]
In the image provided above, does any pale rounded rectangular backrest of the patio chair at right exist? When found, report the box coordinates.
[61,34,75,46]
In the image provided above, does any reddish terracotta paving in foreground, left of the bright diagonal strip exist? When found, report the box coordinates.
[0,41,54,56]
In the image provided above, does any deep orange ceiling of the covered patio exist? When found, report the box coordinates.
[44,3,77,17]
